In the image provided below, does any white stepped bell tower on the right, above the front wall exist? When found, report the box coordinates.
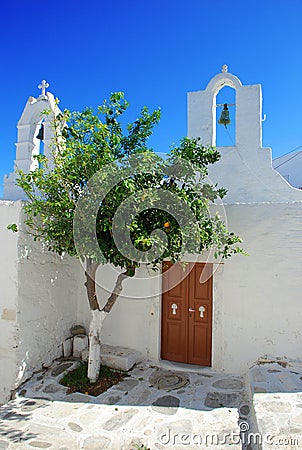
[188,65,301,204]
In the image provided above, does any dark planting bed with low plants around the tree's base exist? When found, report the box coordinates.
[60,362,128,396]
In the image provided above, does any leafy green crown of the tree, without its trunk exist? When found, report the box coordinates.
[13,92,242,270]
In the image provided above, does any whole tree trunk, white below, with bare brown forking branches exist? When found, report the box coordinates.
[85,258,130,383]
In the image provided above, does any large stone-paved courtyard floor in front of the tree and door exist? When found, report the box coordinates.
[0,360,250,450]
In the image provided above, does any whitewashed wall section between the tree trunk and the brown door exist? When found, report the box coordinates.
[78,265,161,360]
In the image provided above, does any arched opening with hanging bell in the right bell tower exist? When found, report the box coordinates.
[213,86,236,147]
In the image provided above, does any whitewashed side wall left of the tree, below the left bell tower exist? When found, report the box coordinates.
[0,201,80,403]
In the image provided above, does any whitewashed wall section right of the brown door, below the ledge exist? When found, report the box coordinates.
[213,202,302,373]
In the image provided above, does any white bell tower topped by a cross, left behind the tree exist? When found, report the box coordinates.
[3,80,60,200]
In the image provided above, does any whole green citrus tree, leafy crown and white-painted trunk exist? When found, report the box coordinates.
[9,92,242,381]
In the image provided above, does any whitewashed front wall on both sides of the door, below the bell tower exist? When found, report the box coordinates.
[75,195,302,373]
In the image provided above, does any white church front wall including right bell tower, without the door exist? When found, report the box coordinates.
[78,69,302,373]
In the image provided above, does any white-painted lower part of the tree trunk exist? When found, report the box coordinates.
[88,309,108,383]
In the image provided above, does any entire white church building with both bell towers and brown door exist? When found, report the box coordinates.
[0,66,302,402]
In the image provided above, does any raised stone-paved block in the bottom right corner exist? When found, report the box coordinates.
[247,358,302,450]
